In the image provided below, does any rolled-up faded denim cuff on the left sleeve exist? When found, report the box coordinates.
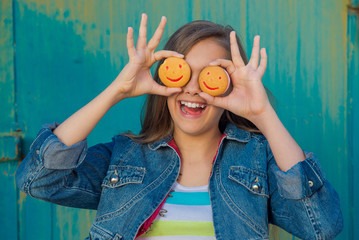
[30,123,87,170]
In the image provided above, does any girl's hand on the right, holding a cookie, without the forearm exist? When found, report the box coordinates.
[200,31,271,124]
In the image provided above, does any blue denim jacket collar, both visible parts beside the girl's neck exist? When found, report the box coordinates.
[148,123,252,150]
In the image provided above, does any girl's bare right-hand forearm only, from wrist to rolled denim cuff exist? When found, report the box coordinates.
[251,107,305,171]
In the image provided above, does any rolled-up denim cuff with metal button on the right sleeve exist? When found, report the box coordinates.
[274,153,325,200]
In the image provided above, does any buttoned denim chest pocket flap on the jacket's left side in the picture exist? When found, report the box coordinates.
[102,165,146,188]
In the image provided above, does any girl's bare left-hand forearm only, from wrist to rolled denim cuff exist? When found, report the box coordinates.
[54,84,125,146]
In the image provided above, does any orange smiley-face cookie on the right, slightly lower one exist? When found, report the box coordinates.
[198,66,230,96]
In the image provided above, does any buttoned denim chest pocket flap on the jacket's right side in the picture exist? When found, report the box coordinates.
[228,166,269,197]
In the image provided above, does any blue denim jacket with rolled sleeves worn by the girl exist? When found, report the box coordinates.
[16,124,343,240]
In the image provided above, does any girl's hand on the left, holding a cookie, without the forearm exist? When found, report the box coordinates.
[111,14,183,101]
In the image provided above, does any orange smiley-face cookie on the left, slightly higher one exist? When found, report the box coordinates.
[158,57,191,87]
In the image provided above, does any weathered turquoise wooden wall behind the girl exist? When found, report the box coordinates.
[0,0,359,240]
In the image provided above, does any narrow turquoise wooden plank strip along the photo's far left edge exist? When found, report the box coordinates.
[0,0,18,239]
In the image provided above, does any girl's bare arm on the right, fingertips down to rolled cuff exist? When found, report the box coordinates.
[199,32,306,171]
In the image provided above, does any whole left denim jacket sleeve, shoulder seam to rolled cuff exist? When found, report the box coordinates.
[16,124,114,209]
